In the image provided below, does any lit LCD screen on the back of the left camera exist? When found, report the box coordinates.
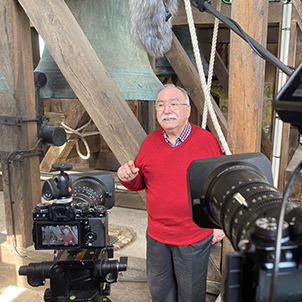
[36,223,80,249]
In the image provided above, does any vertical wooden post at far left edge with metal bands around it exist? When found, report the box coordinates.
[0,0,41,247]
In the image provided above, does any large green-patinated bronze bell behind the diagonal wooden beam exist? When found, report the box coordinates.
[35,0,162,101]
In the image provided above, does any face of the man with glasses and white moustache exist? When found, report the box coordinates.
[156,87,191,134]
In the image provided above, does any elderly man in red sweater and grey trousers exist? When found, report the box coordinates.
[118,85,224,302]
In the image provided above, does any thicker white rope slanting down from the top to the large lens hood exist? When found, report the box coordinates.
[184,0,231,155]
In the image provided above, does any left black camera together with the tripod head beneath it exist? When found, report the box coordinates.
[19,163,127,302]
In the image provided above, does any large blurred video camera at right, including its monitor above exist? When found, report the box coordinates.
[187,63,302,302]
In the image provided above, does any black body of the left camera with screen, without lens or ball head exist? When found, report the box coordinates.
[33,202,109,250]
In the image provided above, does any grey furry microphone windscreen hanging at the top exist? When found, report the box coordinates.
[129,0,178,58]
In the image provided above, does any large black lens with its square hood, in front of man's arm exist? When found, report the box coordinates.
[187,153,290,250]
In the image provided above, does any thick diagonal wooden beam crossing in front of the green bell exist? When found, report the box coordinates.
[19,0,146,168]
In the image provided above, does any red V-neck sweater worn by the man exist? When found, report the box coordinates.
[121,125,222,245]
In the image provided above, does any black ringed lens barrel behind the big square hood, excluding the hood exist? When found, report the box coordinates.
[204,165,282,250]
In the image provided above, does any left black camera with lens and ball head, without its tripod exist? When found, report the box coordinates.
[33,164,114,250]
